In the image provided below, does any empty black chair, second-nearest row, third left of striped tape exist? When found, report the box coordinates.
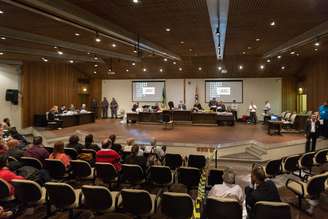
[120,164,145,186]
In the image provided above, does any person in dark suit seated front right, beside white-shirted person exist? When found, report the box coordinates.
[245,165,280,219]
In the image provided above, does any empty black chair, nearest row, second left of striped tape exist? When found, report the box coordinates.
[117,189,156,217]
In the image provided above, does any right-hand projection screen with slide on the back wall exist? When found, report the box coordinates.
[205,80,243,103]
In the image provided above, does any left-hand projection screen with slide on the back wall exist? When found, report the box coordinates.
[132,81,165,102]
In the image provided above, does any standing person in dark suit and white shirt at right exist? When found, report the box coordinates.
[304,114,320,152]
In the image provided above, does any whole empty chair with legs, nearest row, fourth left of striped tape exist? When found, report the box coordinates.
[45,182,79,218]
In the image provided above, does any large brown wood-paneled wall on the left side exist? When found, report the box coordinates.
[22,62,101,127]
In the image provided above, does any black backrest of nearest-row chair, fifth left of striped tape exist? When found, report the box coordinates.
[12,179,42,204]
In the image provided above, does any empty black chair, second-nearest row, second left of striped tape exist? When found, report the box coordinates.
[149,166,173,186]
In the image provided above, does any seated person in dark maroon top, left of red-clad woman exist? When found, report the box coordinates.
[24,136,49,164]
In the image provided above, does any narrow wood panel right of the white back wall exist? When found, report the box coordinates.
[281,78,297,112]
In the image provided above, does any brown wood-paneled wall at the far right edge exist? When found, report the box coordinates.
[298,56,328,111]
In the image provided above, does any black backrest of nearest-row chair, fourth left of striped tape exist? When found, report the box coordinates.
[45,182,77,209]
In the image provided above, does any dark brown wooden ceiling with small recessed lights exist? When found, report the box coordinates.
[0,0,328,79]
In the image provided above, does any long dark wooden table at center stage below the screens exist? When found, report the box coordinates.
[127,110,235,125]
